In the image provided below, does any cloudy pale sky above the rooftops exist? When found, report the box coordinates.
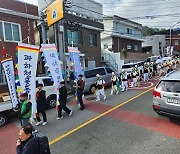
[22,0,180,28]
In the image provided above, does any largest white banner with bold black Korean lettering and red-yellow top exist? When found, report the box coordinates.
[17,43,39,117]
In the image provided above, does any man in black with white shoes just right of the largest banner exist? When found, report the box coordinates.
[36,84,47,126]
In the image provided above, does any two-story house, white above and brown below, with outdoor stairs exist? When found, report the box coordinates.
[101,15,149,71]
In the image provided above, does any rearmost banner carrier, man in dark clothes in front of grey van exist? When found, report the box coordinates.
[76,74,85,110]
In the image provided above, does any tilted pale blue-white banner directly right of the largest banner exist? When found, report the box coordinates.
[41,44,63,89]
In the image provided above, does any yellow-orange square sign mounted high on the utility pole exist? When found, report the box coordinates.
[46,0,64,26]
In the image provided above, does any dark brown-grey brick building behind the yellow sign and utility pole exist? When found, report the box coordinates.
[37,0,104,70]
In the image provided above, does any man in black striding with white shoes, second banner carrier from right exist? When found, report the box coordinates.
[56,81,73,120]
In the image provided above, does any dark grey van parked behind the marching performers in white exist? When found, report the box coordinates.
[84,67,117,93]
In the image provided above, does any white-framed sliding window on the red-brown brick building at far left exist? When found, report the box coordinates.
[3,22,21,42]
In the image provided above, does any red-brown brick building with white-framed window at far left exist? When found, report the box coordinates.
[0,0,39,92]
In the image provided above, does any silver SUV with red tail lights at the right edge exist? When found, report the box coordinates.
[153,71,180,117]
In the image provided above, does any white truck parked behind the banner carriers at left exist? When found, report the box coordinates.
[0,77,56,127]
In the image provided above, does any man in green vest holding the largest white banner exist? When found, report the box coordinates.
[19,93,37,132]
